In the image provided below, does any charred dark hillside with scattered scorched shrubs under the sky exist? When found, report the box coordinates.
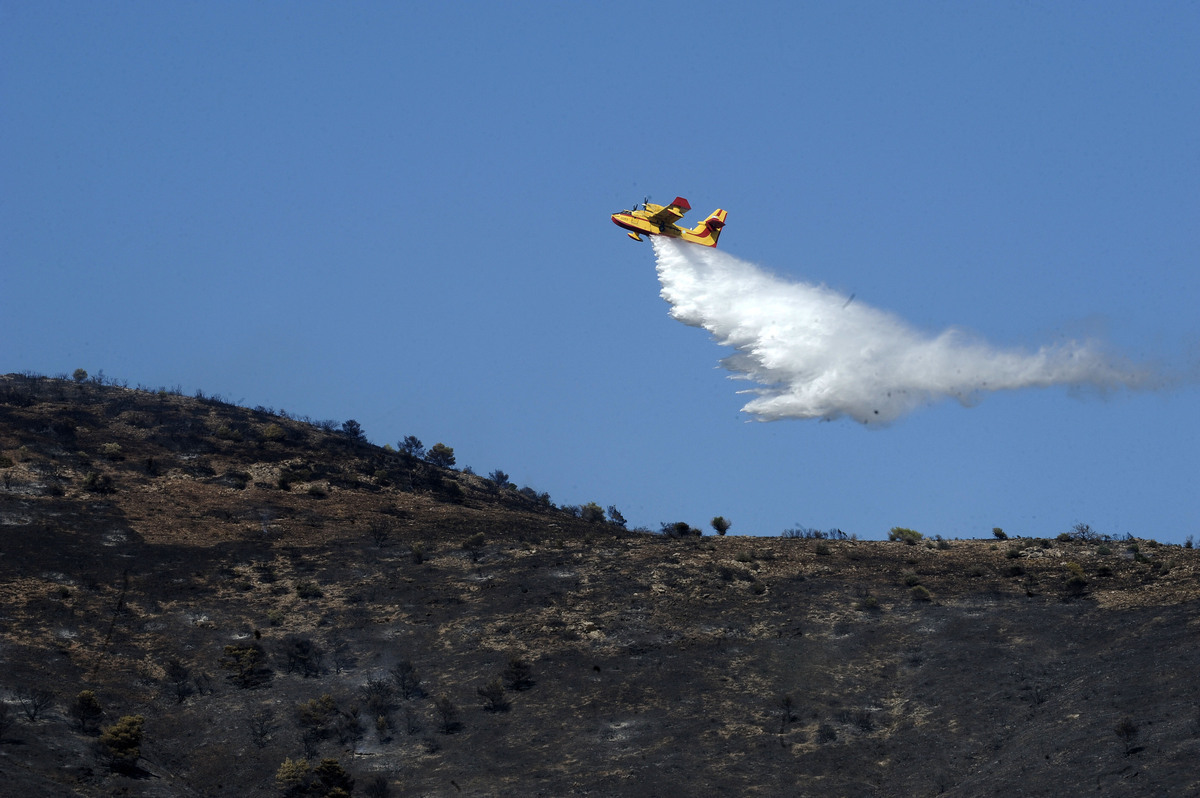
[0,374,1200,797]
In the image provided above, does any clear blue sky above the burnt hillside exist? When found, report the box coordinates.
[0,2,1200,541]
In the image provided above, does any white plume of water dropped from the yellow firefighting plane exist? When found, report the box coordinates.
[652,238,1154,425]
